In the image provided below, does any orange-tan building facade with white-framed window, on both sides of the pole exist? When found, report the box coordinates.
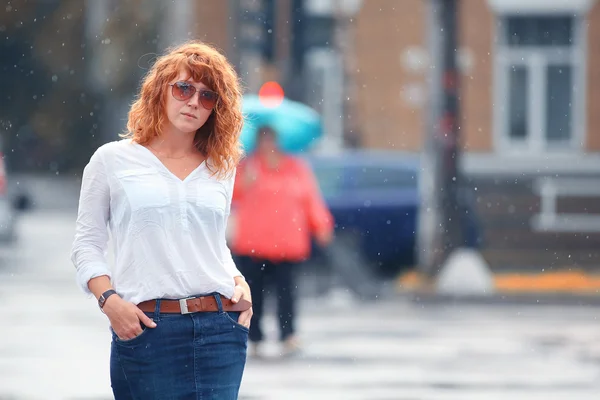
[356,0,600,164]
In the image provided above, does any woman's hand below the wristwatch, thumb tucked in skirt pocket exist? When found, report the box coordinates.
[103,296,156,340]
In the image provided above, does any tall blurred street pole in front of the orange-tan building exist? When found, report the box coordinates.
[417,0,464,277]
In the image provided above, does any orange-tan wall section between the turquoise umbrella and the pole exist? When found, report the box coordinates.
[355,0,427,150]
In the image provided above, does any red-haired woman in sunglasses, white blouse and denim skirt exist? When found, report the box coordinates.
[72,41,252,400]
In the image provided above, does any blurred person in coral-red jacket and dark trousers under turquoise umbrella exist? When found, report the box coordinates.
[230,126,333,356]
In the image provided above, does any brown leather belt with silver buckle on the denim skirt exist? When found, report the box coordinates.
[138,296,252,314]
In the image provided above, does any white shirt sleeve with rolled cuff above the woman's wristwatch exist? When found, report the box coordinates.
[71,148,111,294]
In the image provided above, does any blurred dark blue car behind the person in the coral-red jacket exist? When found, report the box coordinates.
[305,150,479,277]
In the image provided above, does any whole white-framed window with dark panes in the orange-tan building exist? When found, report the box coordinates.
[494,14,585,154]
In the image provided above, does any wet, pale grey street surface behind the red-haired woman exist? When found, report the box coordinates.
[0,210,600,400]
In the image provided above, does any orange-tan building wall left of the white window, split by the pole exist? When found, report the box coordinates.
[356,0,494,151]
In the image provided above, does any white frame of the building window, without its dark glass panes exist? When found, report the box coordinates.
[494,14,587,156]
